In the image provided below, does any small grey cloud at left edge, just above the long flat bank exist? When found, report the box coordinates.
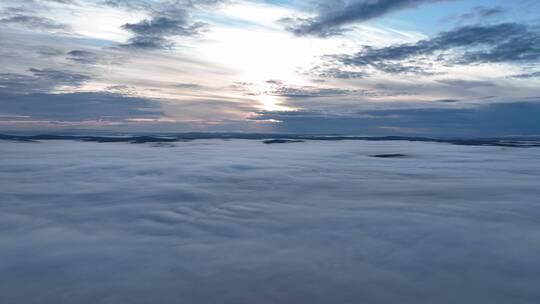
[0,68,90,95]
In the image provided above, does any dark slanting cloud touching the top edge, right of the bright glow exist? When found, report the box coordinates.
[283,0,448,37]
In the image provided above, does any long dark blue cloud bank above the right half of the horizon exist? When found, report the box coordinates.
[256,99,540,137]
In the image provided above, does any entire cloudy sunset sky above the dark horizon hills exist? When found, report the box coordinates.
[0,0,540,137]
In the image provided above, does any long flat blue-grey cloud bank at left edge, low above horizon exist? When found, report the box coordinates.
[0,92,163,121]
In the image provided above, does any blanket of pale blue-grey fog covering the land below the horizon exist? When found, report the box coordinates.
[0,140,540,304]
